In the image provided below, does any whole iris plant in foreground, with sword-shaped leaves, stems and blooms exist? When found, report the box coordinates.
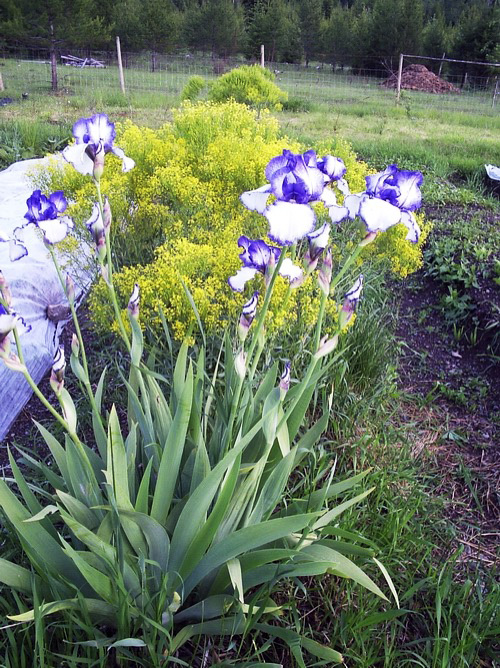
[0,109,422,666]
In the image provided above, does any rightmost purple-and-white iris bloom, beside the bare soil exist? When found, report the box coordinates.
[344,165,424,243]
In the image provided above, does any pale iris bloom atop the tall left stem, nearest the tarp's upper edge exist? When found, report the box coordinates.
[63,114,135,180]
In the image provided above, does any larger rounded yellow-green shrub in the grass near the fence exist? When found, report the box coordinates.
[208,65,288,110]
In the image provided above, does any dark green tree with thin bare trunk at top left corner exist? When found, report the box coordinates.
[0,0,110,91]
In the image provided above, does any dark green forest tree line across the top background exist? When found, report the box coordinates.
[0,0,500,73]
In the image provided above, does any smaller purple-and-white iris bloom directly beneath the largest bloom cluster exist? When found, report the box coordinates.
[228,236,303,292]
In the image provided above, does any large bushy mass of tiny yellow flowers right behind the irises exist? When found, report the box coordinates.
[37,102,428,340]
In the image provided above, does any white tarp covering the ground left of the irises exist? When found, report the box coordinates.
[0,157,89,441]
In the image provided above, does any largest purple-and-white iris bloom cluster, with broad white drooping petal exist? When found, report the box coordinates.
[240,149,345,246]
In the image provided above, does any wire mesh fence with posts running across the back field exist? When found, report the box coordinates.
[0,49,500,115]
